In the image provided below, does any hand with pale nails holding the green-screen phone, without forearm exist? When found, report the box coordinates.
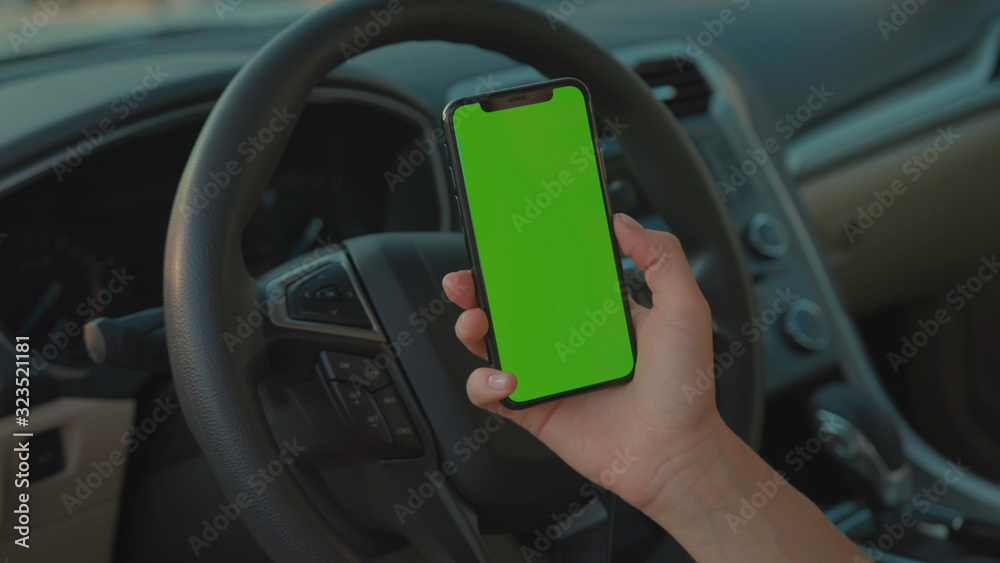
[443,214,729,510]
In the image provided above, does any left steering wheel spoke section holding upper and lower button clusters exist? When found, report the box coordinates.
[255,247,423,459]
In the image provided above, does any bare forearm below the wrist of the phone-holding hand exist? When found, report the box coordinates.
[643,420,869,563]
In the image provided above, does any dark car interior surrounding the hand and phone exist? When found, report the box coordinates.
[0,0,1000,563]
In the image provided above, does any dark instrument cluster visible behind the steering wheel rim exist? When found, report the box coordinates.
[0,92,442,373]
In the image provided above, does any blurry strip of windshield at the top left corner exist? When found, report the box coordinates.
[0,0,324,60]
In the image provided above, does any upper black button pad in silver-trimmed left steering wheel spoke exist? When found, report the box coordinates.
[286,262,372,328]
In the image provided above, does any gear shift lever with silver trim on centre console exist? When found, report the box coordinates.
[809,383,913,511]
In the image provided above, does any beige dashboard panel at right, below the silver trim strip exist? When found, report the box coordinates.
[800,108,1000,316]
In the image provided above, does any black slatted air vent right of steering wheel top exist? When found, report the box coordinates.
[635,57,712,117]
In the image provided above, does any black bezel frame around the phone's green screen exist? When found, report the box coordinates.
[442,78,637,410]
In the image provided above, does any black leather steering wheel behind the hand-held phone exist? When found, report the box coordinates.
[164,0,763,562]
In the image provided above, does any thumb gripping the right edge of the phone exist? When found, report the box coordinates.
[614,213,704,312]
